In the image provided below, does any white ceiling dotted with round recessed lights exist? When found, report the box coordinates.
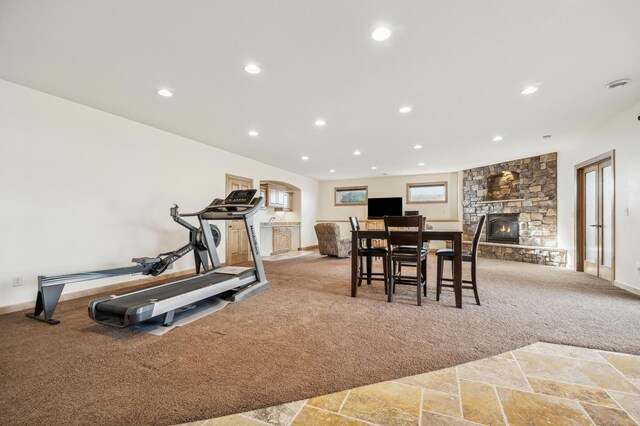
[0,0,640,179]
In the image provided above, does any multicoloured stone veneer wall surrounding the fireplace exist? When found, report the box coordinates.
[462,152,566,265]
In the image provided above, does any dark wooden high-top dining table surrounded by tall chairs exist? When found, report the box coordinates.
[351,229,462,308]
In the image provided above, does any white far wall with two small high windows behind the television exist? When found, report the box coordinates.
[318,172,461,240]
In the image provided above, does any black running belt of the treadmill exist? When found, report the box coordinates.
[96,269,255,315]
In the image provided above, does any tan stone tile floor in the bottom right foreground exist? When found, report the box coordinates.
[179,342,640,426]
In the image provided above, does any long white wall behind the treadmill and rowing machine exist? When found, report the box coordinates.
[0,80,319,306]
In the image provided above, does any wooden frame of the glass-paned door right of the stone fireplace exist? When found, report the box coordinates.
[574,149,616,283]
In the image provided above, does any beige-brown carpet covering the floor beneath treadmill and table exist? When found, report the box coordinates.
[0,255,640,425]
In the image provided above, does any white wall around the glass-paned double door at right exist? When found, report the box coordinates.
[558,103,640,290]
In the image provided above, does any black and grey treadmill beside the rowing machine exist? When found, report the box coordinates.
[89,189,269,327]
